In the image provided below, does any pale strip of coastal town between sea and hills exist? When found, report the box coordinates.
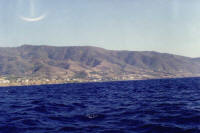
[0,71,200,86]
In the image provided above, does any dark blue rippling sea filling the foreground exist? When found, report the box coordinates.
[0,78,200,133]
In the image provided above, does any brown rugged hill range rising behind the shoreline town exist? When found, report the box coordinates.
[0,45,200,78]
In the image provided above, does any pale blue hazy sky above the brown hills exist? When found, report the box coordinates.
[0,0,200,57]
